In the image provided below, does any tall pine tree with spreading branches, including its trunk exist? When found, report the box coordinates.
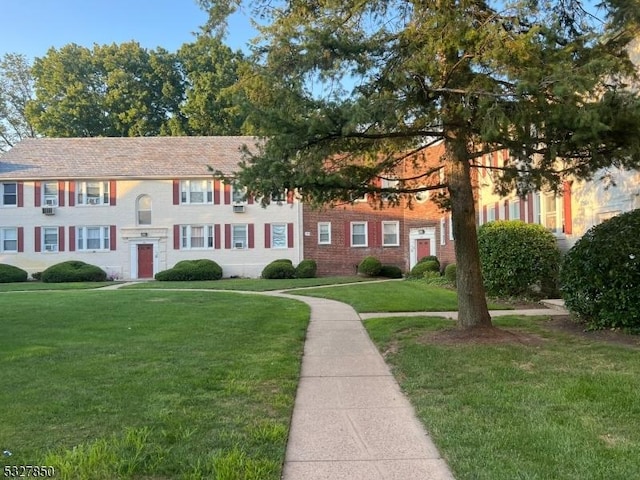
[199,0,640,328]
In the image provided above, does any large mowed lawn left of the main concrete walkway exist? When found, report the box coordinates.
[0,291,309,480]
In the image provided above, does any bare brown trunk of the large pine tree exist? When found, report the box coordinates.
[445,140,492,328]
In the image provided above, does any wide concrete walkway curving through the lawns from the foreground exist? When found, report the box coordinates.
[274,293,453,480]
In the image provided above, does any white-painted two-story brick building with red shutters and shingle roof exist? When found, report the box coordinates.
[0,137,302,279]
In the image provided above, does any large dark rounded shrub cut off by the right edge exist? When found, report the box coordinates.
[560,209,640,331]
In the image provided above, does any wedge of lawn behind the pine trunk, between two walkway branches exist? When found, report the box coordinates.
[296,280,507,313]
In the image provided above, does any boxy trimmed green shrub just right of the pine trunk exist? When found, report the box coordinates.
[478,220,560,297]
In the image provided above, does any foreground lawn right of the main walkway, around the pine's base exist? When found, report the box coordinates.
[366,317,640,480]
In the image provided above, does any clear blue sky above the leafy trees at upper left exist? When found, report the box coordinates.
[0,0,252,61]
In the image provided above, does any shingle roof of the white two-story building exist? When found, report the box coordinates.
[0,136,257,180]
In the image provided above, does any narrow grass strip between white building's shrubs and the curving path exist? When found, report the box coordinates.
[123,276,372,292]
